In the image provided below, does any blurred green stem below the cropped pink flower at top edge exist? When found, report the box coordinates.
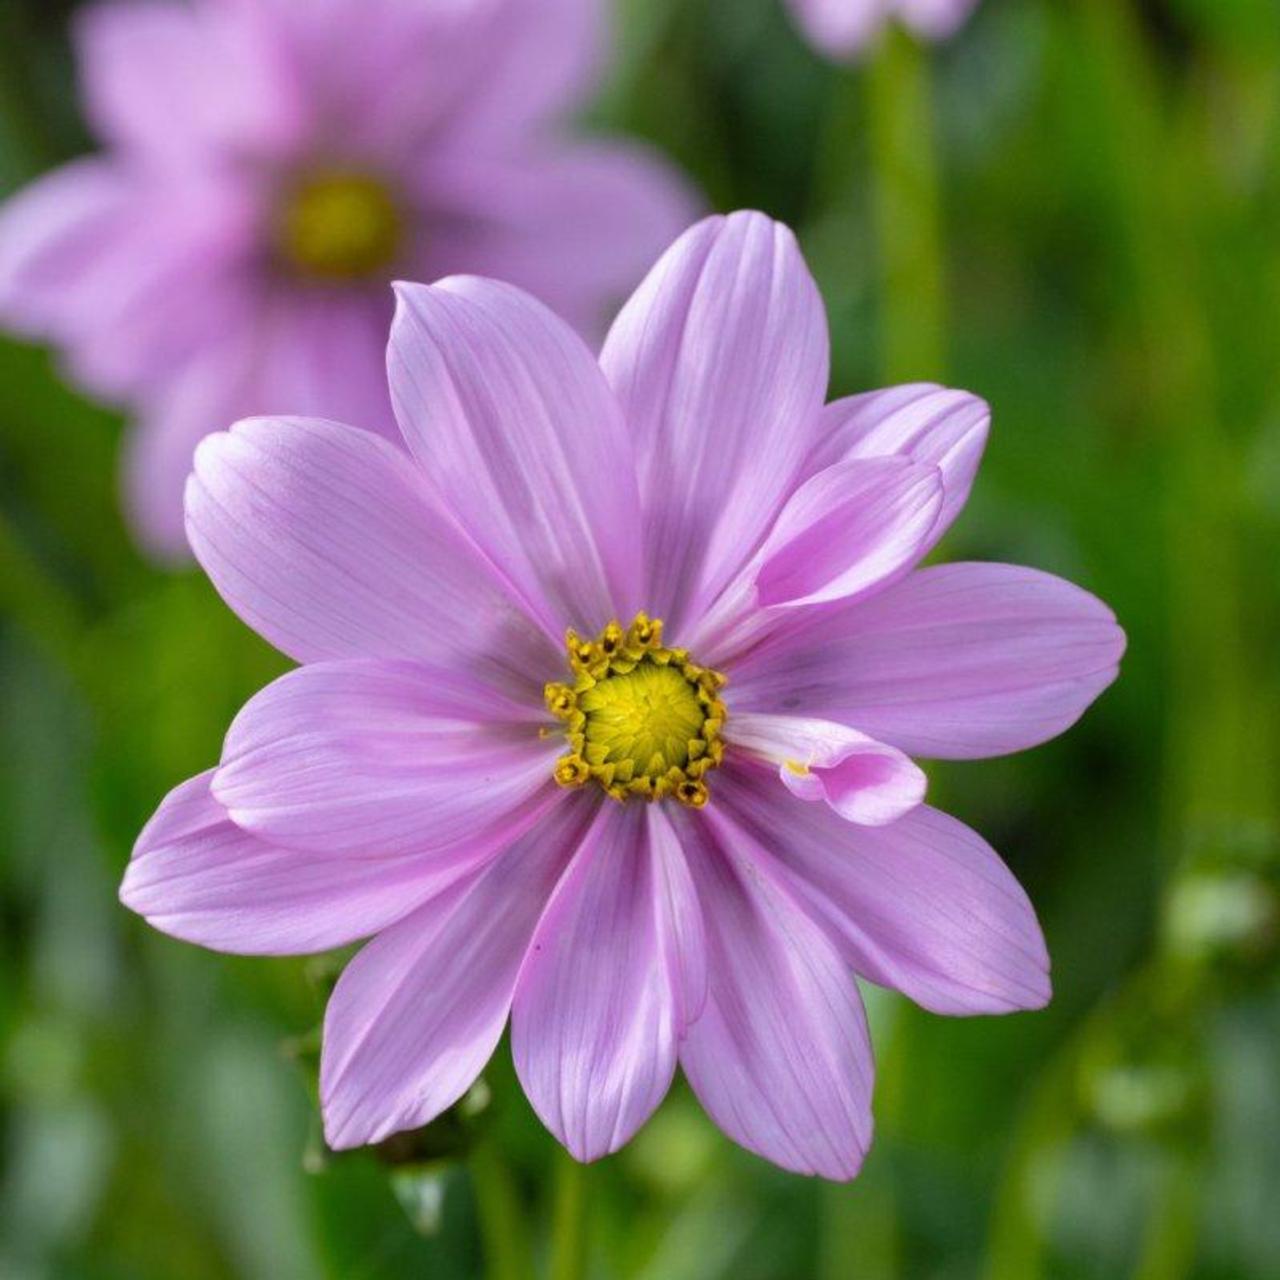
[867,28,946,383]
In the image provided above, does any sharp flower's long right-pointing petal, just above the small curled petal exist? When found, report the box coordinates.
[733,564,1125,759]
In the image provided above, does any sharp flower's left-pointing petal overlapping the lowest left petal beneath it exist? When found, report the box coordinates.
[212,660,563,860]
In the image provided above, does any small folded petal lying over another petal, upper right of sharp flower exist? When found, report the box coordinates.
[755,458,942,608]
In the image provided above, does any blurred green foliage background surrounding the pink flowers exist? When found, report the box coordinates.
[0,0,1280,1280]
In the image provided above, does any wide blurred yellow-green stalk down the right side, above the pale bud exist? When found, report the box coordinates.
[1078,0,1272,839]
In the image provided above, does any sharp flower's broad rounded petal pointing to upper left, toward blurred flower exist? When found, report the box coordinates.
[187,419,562,680]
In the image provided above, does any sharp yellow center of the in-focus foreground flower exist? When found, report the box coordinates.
[545,613,726,809]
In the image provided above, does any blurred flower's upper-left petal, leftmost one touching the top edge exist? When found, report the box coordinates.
[74,0,302,165]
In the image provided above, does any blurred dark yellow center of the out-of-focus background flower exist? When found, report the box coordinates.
[276,169,404,280]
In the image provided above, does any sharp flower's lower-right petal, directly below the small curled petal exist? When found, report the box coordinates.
[717,774,1050,1014]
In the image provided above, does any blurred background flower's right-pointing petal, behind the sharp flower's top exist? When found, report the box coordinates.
[411,140,698,338]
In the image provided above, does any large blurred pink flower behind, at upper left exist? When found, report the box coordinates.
[0,0,692,556]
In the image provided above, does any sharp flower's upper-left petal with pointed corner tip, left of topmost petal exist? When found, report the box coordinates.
[388,276,640,640]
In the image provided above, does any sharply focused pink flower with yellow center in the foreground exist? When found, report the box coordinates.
[122,212,1124,1178]
